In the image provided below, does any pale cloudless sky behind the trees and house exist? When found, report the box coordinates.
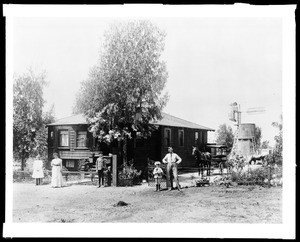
[13,17,282,145]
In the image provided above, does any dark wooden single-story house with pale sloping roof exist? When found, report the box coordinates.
[47,113,214,171]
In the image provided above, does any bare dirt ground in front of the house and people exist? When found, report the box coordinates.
[13,173,282,224]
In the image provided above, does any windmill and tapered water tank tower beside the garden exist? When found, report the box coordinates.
[229,102,265,158]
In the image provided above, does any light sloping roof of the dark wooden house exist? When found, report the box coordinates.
[47,113,214,131]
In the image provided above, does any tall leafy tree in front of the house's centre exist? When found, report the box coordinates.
[75,20,168,164]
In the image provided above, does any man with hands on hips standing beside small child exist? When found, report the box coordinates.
[162,147,181,191]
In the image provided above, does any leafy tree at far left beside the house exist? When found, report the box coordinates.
[13,69,53,170]
